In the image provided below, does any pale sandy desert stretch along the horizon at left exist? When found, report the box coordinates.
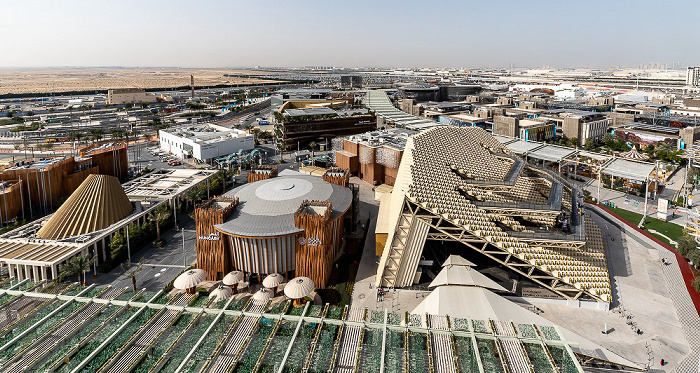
[0,68,282,95]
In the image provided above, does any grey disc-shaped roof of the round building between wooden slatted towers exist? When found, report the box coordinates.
[215,172,352,237]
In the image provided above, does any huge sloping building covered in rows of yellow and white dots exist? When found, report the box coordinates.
[375,126,608,302]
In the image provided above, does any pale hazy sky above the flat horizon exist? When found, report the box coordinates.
[0,0,700,68]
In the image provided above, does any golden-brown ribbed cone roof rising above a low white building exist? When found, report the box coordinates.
[36,175,133,240]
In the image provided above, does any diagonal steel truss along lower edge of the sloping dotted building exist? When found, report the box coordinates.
[402,198,604,302]
